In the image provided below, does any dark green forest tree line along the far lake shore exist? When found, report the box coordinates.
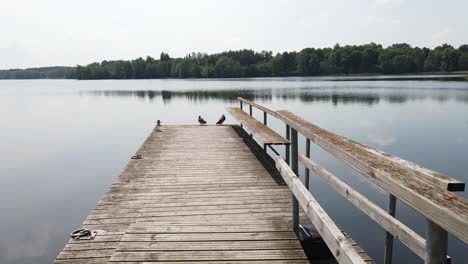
[0,43,468,79]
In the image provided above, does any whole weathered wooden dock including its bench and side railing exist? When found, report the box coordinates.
[56,98,468,264]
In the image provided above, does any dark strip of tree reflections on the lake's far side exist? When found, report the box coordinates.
[86,89,468,106]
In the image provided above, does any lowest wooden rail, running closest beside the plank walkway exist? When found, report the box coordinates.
[276,156,366,264]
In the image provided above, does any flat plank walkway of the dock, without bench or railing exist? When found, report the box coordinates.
[56,125,308,264]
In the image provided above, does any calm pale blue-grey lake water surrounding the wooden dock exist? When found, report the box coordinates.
[0,77,468,264]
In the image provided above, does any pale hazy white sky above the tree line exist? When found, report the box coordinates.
[0,0,468,69]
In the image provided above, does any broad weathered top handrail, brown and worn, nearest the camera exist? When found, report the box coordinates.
[277,110,468,243]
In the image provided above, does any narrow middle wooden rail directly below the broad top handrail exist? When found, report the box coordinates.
[299,155,425,259]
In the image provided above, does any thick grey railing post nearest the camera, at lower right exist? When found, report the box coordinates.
[424,219,448,264]
